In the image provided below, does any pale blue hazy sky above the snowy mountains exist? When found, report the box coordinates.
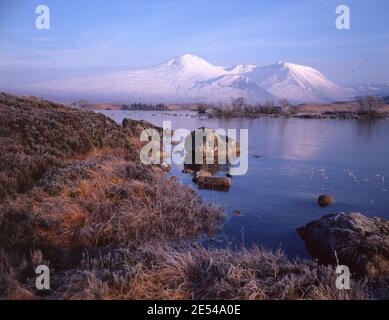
[0,0,389,90]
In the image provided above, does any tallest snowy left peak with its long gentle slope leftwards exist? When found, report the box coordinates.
[34,54,226,102]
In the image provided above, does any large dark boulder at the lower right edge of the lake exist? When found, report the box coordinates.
[297,212,389,277]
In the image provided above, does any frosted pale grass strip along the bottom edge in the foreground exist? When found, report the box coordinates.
[53,245,370,300]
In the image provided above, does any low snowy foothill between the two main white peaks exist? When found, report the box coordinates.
[191,74,276,103]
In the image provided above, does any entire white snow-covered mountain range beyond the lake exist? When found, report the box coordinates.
[29,54,366,103]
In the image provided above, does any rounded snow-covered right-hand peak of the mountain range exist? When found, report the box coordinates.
[244,62,353,102]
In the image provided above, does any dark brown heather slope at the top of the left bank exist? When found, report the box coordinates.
[0,93,137,201]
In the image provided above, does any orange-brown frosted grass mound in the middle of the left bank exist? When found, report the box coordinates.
[0,157,223,263]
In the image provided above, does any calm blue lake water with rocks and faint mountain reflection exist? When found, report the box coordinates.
[97,111,389,257]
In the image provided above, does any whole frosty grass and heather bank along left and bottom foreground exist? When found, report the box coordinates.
[0,94,382,299]
